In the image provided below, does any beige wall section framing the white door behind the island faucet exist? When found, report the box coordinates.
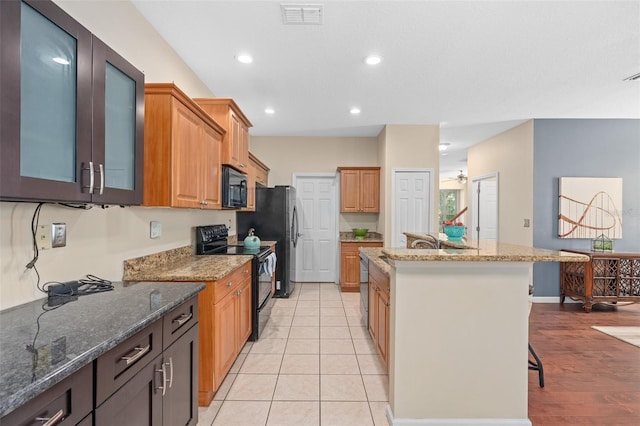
[378,125,440,247]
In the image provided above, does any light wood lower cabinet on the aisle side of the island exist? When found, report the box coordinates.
[369,262,391,371]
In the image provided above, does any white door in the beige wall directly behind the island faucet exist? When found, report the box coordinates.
[391,169,433,247]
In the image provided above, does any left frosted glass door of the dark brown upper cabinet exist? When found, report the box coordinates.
[0,1,91,201]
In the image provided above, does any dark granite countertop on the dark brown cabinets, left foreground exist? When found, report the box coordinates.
[0,282,205,416]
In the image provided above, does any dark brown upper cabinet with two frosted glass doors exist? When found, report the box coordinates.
[0,0,144,205]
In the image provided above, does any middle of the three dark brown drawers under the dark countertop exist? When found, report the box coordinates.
[96,320,162,406]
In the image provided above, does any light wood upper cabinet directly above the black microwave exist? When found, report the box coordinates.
[194,98,252,173]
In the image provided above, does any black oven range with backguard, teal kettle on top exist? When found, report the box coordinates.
[195,225,275,341]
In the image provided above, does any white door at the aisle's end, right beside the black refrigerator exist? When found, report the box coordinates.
[294,175,338,282]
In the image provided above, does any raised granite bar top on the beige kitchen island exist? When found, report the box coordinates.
[382,240,589,262]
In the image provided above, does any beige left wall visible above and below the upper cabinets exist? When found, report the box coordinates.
[0,1,230,309]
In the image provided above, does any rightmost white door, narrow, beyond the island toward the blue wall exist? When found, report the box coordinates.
[469,174,498,240]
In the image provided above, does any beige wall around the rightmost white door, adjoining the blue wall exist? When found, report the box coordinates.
[467,120,533,246]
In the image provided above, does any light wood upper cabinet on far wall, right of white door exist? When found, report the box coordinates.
[338,167,380,213]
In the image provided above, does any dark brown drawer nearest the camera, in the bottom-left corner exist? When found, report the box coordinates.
[0,364,93,426]
